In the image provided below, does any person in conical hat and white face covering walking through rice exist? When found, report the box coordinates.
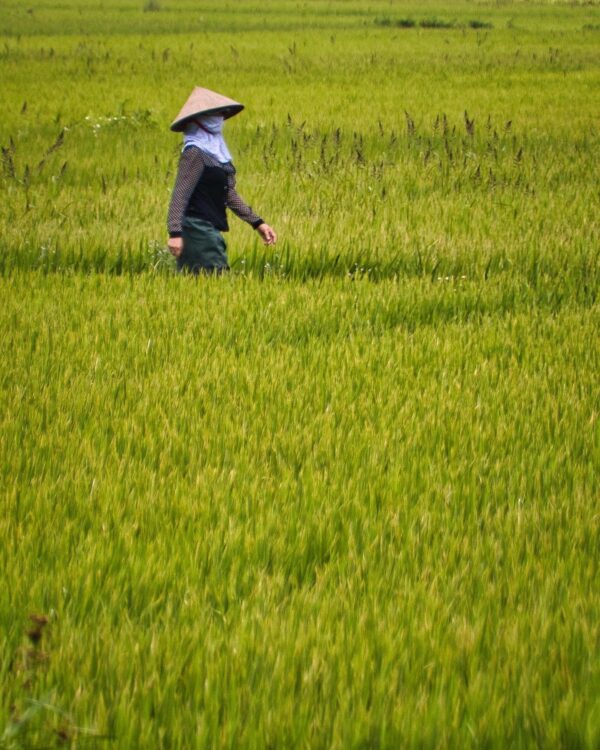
[167,87,277,274]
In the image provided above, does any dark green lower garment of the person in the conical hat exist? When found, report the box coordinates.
[177,216,229,274]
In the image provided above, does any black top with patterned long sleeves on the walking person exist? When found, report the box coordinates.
[167,146,263,237]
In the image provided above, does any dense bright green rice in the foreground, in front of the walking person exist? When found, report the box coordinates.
[0,272,600,747]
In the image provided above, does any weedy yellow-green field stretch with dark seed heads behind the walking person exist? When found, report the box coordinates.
[0,3,599,286]
